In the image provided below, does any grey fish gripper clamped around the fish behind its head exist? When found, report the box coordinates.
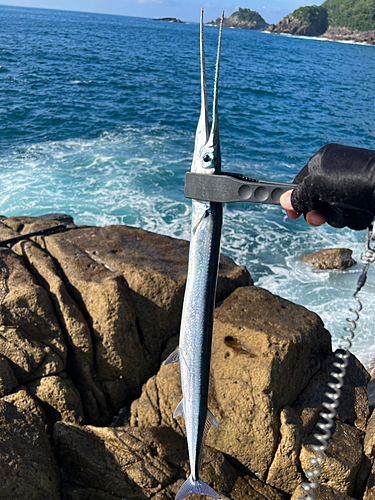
[185,172,296,205]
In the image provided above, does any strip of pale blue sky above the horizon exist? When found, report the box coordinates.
[0,0,323,23]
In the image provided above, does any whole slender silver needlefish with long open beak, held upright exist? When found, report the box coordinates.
[165,9,224,500]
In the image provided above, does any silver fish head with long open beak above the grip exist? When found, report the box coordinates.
[191,9,224,178]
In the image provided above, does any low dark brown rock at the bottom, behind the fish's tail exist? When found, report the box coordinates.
[54,423,283,500]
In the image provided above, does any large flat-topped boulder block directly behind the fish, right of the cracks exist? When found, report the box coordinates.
[37,221,250,413]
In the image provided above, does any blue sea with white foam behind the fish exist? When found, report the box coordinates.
[0,6,375,369]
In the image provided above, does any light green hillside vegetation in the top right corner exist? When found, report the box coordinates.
[322,0,375,31]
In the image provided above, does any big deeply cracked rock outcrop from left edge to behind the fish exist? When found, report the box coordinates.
[0,214,252,425]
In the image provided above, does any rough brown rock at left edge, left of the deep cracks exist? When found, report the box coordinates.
[0,249,66,382]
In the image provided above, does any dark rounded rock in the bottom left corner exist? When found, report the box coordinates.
[0,401,60,500]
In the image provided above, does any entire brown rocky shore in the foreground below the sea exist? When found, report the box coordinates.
[0,215,375,500]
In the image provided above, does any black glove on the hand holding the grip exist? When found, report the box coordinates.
[291,144,375,231]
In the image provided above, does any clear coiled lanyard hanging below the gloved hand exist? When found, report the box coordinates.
[298,224,375,500]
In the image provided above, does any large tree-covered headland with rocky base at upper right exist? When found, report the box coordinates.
[268,0,375,45]
